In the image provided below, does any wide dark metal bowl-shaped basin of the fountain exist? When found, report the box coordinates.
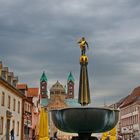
[51,107,119,134]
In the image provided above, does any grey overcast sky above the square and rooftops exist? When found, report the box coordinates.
[0,0,140,106]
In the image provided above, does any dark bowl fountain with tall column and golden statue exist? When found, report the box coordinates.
[52,38,119,140]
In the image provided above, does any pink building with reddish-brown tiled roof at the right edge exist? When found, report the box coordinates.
[119,87,140,140]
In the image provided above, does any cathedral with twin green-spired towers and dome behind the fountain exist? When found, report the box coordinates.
[40,72,77,137]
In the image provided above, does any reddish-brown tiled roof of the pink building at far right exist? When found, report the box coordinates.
[121,86,140,108]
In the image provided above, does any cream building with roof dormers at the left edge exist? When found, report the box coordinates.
[0,62,24,140]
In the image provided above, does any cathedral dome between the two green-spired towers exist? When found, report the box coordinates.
[50,81,65,94]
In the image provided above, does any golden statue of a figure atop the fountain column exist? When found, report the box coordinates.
[78,37,89,55]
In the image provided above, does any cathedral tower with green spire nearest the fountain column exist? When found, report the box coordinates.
[66,72,74,99]
